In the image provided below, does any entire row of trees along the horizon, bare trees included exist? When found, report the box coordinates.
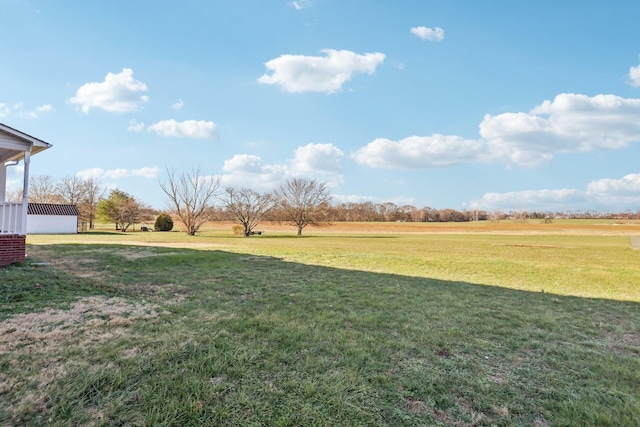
[7,170,640,236]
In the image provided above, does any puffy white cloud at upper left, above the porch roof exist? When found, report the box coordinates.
[68,68,149,113]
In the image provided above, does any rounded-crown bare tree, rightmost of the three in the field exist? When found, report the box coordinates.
[274,178,331,236]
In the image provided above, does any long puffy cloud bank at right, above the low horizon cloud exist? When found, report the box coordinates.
[352,93,640,169]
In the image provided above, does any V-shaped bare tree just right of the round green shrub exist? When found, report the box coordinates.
[160,169,220,236]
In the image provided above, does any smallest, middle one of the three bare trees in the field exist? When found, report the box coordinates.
[223,187,273,237]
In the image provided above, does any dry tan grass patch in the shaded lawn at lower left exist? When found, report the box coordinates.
[0,296,164,420]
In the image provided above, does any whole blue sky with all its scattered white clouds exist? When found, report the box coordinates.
[0,0,640,212]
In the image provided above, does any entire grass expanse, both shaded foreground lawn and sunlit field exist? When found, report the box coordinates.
[0,222,640,426]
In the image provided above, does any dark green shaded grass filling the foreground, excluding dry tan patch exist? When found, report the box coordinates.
[0,244,640,426]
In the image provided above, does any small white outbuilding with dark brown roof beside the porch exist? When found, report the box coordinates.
[27,203,80,234]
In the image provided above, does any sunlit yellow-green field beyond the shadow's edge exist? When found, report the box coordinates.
[27,220,640,302]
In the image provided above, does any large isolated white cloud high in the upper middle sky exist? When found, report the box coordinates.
[258,49,385,93]
